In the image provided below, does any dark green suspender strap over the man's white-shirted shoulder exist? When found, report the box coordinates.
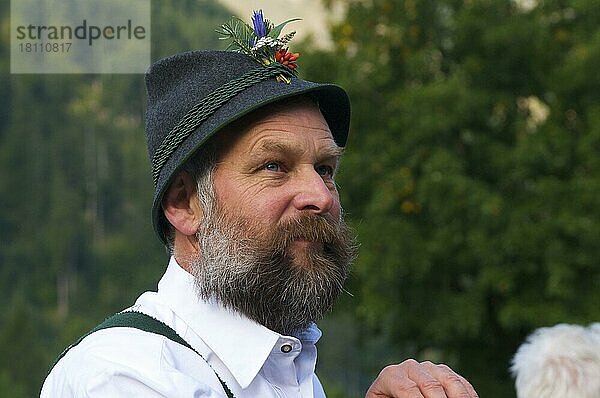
[50,311,235,398]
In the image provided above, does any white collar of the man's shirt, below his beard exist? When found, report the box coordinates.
[158,257,321,388]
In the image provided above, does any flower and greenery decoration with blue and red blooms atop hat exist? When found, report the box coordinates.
[217,10,300,83]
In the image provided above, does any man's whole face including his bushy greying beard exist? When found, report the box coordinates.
[193,99,355,334]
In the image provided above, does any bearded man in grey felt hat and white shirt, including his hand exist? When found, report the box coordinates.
[42,34,476,398]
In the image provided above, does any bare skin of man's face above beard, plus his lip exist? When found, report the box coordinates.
[214,100,341,246]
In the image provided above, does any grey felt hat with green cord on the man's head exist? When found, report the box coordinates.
[146,51,350,243]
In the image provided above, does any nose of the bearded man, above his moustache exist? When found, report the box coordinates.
[293,169,337,214]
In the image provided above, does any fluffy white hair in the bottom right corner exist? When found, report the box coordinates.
[510,323,600,398]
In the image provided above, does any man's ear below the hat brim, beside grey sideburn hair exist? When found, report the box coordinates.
[162,171,203,236]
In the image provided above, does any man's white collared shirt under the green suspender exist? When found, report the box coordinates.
[41,258,325,398]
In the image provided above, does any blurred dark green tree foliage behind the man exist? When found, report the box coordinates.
[0,0,600,398]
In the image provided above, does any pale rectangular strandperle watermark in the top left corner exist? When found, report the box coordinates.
[10,0,150,73]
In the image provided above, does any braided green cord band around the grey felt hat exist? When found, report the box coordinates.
[152,62,292,187]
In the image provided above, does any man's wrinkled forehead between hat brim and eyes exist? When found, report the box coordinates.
[219,99,339,157]
